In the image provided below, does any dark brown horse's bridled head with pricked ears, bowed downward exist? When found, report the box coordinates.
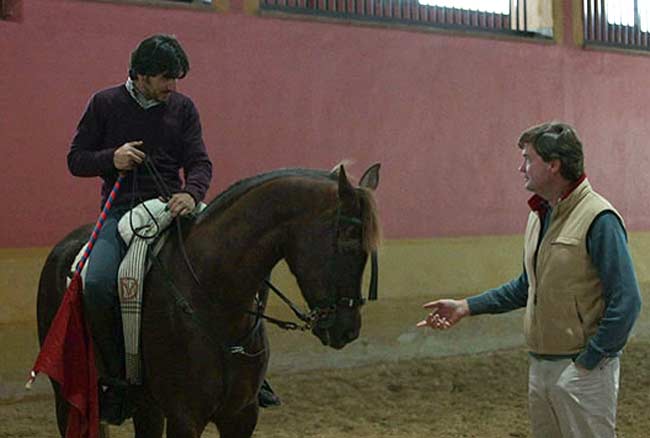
[286,164,379,349]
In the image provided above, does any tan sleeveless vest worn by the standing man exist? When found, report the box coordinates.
[524,179,623,354]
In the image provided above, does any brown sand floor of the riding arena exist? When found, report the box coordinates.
[0,340,650,438]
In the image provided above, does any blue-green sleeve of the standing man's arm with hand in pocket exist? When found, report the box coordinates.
[575,211,641,369]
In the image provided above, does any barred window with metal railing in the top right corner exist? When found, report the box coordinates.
[583,0,650,50]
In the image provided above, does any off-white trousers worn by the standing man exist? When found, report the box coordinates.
[528,357,620,438]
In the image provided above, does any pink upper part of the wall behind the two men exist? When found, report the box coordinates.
[0,0,650,247]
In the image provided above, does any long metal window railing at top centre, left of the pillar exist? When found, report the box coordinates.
[260,0,549,38]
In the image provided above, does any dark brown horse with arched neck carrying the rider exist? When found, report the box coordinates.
[38,165,379,438]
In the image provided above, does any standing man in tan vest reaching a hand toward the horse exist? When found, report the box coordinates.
[417,122,641,438]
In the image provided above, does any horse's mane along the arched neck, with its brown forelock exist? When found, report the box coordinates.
[196,168,381,251]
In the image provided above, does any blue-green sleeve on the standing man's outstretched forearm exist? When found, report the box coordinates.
[467,270,528,315]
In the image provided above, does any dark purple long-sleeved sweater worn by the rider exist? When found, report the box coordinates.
[68,85,212,208]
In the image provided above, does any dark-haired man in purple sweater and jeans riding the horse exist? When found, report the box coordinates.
[68,35,279,424]
